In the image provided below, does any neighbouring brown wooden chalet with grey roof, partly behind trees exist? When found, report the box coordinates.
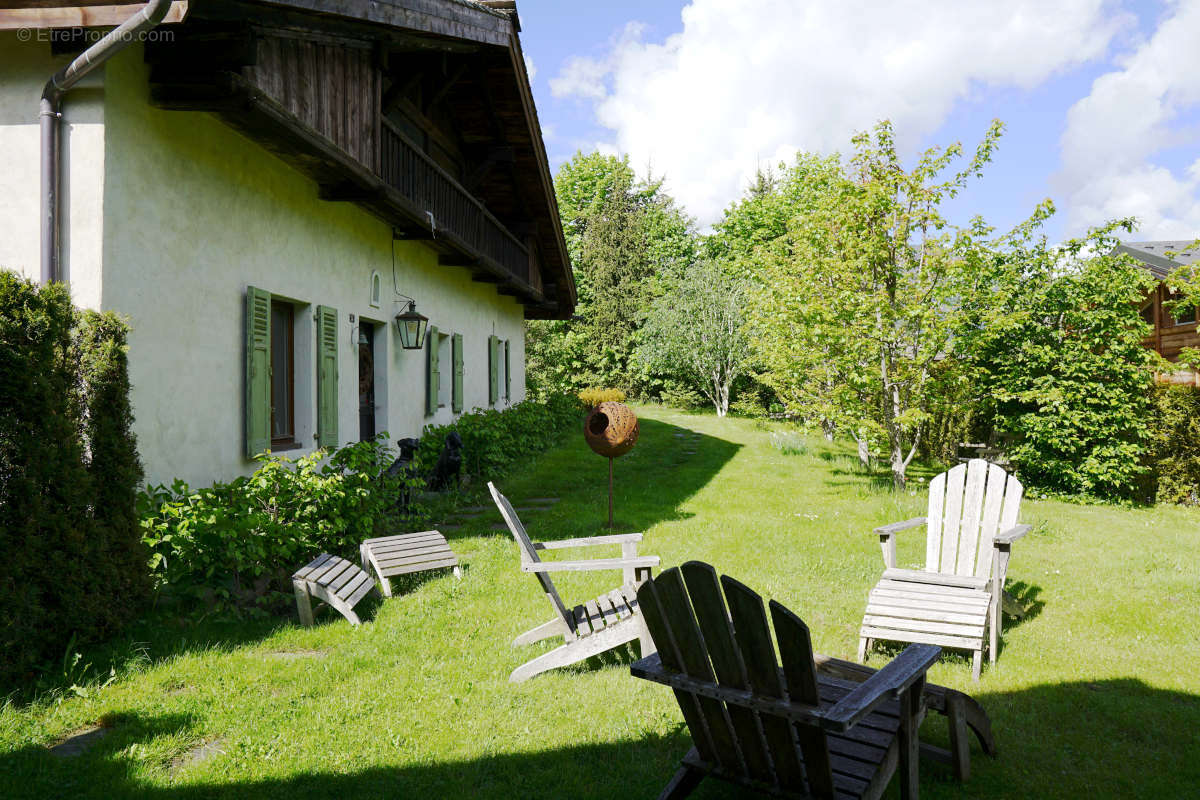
[1116,241,1200,385]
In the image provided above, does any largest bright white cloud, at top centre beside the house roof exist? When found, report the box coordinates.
[550,0,1130,223]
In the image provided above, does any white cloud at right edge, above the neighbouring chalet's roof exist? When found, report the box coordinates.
[1056,2,1200,239]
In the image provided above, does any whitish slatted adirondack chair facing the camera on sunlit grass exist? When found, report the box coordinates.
[858,458,1030,680]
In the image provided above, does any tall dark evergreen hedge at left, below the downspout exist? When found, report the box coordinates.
[0,270,149,686]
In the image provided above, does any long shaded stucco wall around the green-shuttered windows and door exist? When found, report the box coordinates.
[102,47,524,485]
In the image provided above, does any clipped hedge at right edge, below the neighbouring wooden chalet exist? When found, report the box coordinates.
[1151,385,1200,505]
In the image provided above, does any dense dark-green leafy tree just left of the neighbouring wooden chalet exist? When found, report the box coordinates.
[960,215,1158,498]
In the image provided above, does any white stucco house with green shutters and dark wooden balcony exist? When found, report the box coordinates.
[0,0,575,485]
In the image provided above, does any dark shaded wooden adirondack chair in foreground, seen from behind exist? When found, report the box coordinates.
[631,561,941,800]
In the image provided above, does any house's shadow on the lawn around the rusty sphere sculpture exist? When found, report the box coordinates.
[458,419,742,541]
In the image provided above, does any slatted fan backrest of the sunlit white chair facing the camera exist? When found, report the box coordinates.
[925,458,1025,578]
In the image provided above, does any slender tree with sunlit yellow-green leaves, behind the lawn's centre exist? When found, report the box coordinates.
[751,122,1002,488]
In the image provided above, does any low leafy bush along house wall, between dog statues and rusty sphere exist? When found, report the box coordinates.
[416,395,583,479]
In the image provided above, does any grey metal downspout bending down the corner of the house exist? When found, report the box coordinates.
[38,0,172,284]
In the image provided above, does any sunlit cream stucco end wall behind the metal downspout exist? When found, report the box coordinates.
[0,30,104,308]
